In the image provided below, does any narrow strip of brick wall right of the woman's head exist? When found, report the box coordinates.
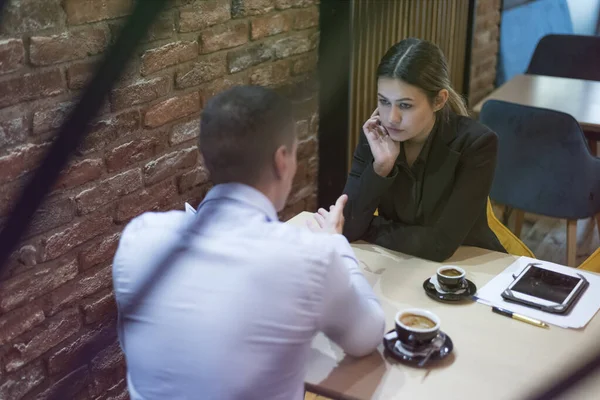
[469,0,501,107]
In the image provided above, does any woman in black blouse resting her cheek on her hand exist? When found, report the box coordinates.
[338,38,505,261]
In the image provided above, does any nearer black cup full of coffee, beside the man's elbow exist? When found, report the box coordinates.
[395,308,440,348]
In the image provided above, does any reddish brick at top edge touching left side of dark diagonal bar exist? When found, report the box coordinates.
[64,0,133,25]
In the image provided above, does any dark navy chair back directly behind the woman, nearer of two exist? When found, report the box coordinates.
[480,100,600,219]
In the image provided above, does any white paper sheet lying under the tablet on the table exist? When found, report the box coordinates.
[476,257,600,328]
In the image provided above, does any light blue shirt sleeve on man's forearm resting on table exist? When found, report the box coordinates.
[319,235,385,357]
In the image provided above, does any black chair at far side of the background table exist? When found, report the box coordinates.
[526,35,600,155]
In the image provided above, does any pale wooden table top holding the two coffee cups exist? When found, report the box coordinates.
[289,212,600,400]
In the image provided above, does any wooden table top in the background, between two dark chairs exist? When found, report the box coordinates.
[473,75,600,132]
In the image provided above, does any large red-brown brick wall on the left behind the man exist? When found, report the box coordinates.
[0,0,319,400]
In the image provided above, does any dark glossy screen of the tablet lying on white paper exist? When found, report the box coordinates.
[512,266,581,304]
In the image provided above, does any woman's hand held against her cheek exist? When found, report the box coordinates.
[363,109,400,177]
